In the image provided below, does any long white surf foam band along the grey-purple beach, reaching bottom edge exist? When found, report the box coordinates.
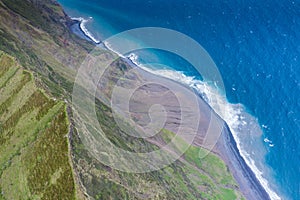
[127,53,281,200]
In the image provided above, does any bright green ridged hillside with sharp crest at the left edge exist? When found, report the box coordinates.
[0,52,75,199]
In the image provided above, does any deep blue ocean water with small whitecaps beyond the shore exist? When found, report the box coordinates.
[59,0,300,199]
